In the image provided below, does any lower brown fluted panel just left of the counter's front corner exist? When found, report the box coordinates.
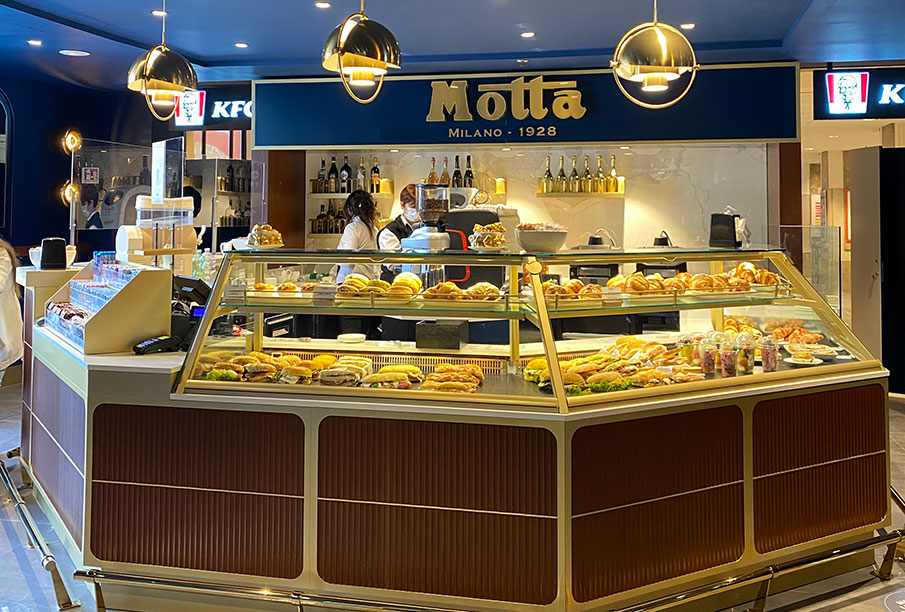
[317,500,557,604]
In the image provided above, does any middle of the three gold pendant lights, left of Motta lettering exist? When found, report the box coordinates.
[322,0,402,104]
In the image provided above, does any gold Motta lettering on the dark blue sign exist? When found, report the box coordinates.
[427,76,587,121]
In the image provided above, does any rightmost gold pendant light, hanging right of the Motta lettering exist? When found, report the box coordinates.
[610,0,700,109]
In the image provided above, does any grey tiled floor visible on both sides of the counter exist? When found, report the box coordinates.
[0,387,905,612]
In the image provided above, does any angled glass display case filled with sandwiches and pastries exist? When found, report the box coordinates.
[176,248,880,413]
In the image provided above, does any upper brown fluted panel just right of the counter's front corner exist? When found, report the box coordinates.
[572,406,744,515]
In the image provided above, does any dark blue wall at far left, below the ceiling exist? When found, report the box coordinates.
[0,68,151,246]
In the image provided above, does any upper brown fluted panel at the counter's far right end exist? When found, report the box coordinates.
[754,384,886,476]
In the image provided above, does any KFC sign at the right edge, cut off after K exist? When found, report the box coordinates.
[814,68,905,119]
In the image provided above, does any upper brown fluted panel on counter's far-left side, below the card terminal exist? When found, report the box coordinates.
[31,359,85,472]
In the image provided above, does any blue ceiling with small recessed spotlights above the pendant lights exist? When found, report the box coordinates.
[0,0,905,88]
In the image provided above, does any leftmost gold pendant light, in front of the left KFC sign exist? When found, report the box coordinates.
[127,0,198,121]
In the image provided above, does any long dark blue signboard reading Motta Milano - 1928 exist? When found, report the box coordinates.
[253,64,799,149]
